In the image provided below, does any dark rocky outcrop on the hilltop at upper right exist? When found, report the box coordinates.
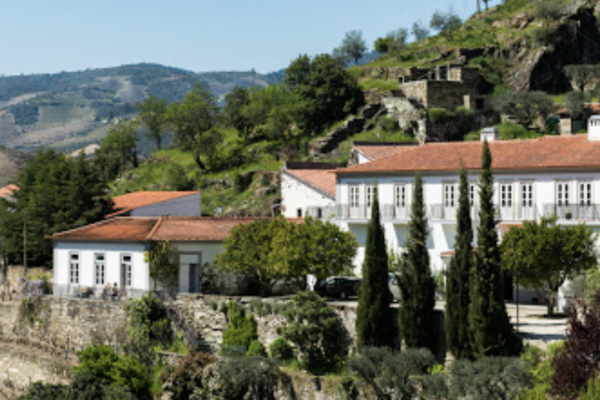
[508,2,600,94]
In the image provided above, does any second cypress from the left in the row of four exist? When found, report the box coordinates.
[398,173,436,348]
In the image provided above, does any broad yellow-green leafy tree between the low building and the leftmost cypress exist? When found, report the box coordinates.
[215,217,358,295]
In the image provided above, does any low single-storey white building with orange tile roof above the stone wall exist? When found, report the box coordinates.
[50,217,264,297]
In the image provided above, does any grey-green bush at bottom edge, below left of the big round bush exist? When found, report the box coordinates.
[218,357,280,400]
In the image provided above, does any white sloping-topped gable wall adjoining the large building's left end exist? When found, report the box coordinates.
[281,171,335,219]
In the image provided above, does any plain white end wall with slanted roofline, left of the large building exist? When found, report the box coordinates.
[281,171,335,218]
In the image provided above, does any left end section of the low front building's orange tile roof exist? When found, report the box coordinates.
[48,217,159,242]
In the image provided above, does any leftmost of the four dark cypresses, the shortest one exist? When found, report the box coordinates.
[356,194,396,349]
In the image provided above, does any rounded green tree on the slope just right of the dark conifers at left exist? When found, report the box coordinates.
[95,122,139,180]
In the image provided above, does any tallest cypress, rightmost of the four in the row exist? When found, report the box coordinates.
[469,141,512,357]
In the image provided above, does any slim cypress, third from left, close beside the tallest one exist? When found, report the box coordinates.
[445,166,473,358]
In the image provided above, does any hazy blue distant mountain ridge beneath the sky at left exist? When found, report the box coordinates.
[0,64,282,151]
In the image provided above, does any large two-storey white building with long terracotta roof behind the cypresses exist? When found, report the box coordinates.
[335,133,600,308]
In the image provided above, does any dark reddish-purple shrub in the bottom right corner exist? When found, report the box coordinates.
[550,293,600,399]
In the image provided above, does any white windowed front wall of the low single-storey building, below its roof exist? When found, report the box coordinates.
[53,241,223,297]
